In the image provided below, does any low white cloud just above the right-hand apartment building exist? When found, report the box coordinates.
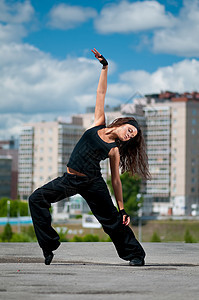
[120,59,199,94]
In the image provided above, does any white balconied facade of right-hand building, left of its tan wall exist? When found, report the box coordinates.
[144,105,171,214]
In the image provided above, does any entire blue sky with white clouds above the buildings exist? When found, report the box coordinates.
[0,0,199,139]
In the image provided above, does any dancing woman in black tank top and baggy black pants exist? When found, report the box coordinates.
[29,49,150,266]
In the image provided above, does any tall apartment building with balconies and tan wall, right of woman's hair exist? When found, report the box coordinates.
[143,93,199,215]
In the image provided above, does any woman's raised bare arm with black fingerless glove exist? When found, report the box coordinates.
[91,48,108,126]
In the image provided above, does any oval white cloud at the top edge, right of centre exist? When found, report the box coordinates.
[95,1,175,34]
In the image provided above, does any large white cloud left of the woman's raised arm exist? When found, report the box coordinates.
[0,44,100,113]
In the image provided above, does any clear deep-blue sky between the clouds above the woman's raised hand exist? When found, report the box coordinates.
[24,0,183,75]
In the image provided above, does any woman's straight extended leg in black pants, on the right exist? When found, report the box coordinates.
[80,177,145,261]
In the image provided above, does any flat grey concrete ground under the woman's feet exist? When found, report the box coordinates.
[0,243,199,300]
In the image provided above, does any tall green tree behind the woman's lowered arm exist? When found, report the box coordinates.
[107,172,143,216]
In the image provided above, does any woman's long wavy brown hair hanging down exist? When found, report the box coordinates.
[107,117,151,179]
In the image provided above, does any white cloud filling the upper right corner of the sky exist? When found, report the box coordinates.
[153,0,199,57]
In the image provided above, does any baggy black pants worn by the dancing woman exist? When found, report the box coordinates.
[29,173,145,260]
